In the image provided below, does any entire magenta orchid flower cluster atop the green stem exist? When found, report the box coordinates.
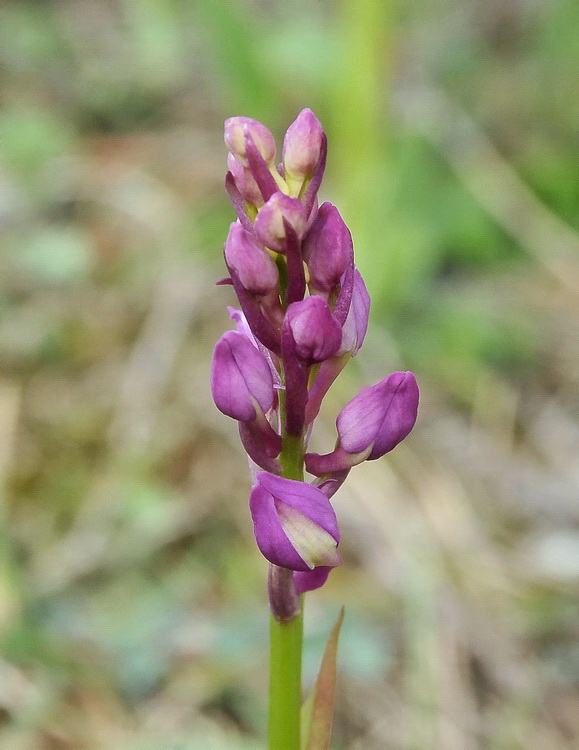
[211,109,419,617]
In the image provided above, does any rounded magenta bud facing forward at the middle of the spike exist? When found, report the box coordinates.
[282,294,342,364]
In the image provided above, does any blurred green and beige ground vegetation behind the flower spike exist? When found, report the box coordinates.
[0,0,579,750]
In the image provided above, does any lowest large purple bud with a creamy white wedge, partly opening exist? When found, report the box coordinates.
[249,471,341,572]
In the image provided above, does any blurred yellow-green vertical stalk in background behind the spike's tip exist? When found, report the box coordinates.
[328,0,394,295]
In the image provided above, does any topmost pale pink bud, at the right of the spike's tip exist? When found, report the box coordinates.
[282,108,324,181]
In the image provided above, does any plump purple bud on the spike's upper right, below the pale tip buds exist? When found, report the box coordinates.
[303,203,354,292]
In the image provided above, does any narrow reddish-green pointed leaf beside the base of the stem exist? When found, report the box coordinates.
[301,607,344,750]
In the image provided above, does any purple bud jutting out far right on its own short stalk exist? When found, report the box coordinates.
[306,372,419,476]
